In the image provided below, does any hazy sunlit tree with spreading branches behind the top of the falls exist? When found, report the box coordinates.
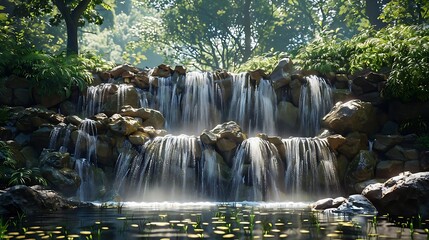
[137,0,290,69]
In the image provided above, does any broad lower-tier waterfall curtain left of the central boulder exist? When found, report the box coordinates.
[126,135,201,201]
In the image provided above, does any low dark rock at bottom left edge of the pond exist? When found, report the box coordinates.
[0,185,88,216]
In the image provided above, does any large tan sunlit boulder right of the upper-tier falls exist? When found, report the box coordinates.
[322,100,378,135]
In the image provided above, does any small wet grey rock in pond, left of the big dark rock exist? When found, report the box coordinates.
[324,194,378,215]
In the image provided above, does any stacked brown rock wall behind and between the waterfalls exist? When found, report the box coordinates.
[0,59,429,201]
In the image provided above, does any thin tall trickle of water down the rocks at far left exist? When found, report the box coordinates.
[74,119,97,201]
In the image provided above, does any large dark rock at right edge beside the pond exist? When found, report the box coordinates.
[362,172,429,218]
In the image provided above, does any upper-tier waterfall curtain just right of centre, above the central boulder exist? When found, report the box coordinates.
[228,73,277,134]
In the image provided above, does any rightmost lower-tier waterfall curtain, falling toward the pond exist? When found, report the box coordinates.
[282,138,339,198]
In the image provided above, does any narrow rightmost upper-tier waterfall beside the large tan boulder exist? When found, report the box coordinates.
[299,75,333,136]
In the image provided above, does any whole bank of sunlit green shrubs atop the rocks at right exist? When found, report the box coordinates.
[295,25,429,101]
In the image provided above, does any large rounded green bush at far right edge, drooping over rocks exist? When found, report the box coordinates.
[350,25,429,101]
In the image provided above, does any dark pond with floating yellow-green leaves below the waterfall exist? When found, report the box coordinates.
[0,202,429,239]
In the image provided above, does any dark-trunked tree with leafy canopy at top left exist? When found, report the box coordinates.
[11,0,111,55]
